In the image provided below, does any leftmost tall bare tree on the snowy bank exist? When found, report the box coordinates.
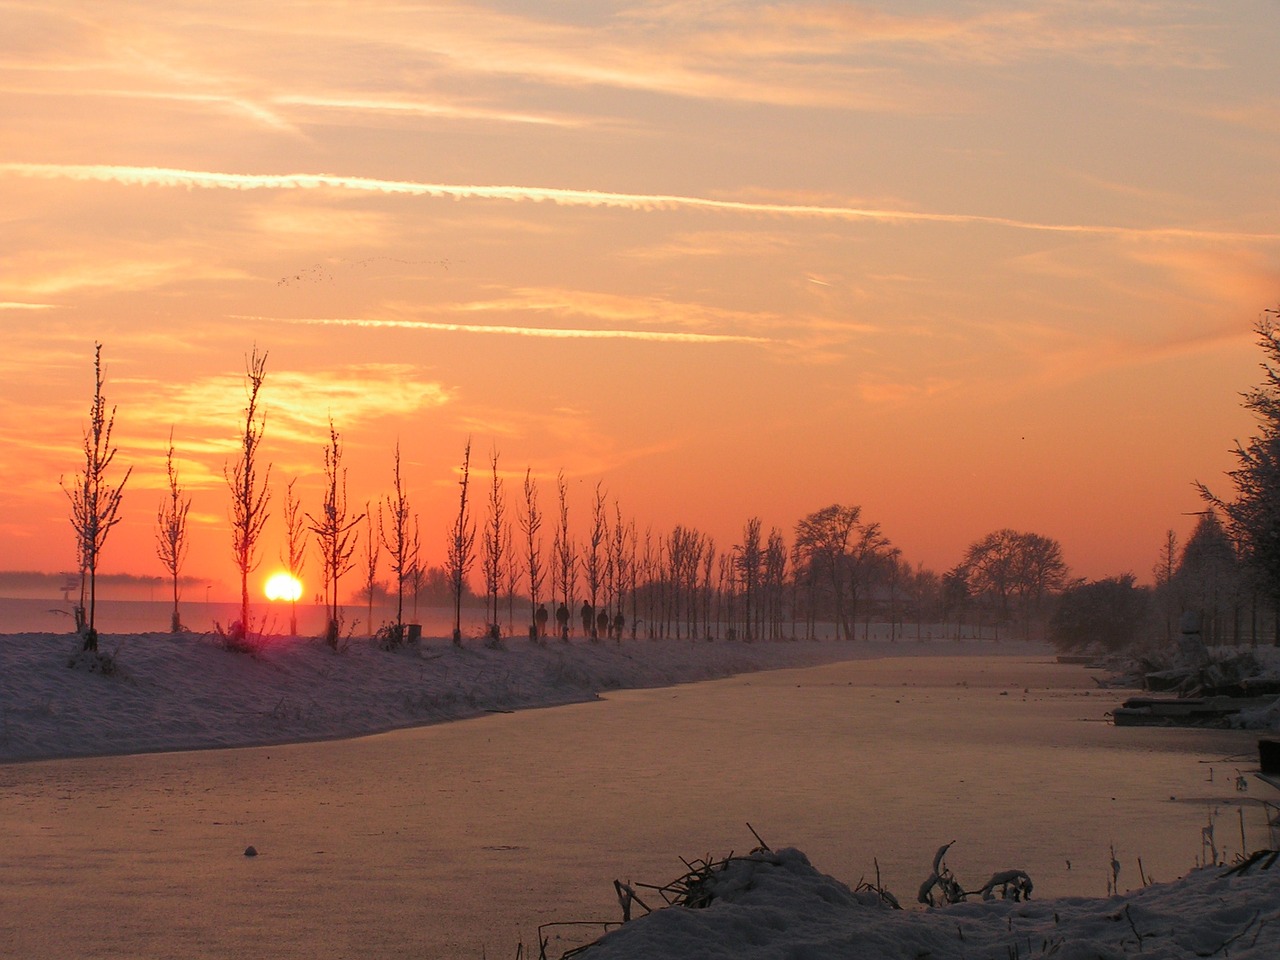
[61,343,133,652]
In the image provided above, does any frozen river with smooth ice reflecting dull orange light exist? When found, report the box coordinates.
[0,657,1267,960]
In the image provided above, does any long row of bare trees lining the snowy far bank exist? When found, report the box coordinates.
[64,346,1066,648]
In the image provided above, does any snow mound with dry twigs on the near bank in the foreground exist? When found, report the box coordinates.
[575,849,1280,960]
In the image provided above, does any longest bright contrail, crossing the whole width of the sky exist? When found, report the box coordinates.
[0,163,1280,242]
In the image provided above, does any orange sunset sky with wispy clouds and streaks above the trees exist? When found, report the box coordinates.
[0,0,1280,601]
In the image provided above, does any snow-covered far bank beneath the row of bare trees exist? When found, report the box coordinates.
[0,634,998,762]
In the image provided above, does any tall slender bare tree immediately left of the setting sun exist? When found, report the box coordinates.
[223,347,271,646]
